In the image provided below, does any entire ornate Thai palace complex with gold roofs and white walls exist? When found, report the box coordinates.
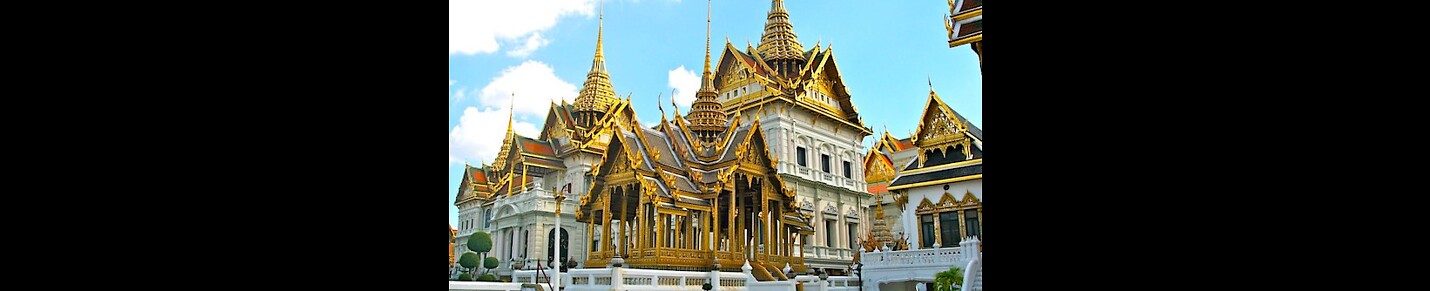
[455,0,982,290]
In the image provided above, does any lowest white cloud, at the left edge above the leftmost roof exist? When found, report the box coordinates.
[448,106,538,165]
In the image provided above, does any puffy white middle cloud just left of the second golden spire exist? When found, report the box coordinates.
[479,60,578,118]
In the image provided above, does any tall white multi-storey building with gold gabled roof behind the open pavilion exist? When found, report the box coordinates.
[712,0,874,274]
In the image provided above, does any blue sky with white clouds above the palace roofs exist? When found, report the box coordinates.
[446,0,982,226]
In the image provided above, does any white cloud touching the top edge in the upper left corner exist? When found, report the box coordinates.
[448,0,596,56]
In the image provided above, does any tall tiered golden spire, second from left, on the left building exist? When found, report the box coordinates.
[575,0,618,128]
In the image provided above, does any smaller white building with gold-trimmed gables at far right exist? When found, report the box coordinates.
[861,87,982,290]
